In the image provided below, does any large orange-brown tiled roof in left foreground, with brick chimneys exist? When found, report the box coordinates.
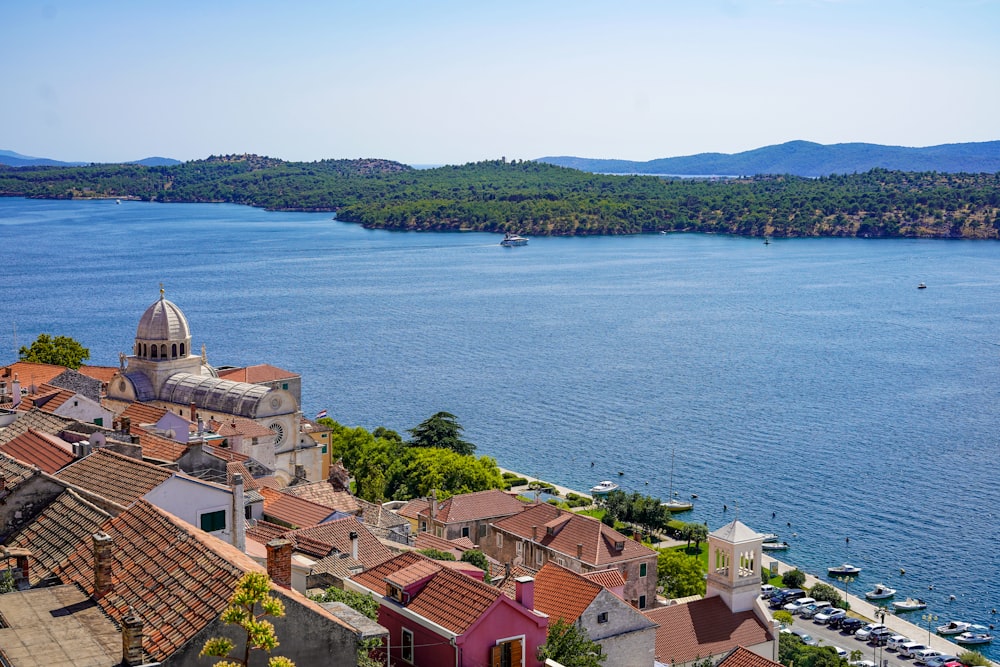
[56,500,353,661]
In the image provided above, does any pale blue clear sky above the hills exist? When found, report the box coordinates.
[0,0,1000,165]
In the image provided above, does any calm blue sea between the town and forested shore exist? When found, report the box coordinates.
[0,199,1000,657]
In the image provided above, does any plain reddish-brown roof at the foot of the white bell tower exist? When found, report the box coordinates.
[643,596,771,663]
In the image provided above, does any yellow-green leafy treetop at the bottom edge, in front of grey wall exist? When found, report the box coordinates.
[199,572,295,667]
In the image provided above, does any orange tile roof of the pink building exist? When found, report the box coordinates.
[351,552,502,635]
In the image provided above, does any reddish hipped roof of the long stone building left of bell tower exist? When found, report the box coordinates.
[494,503,656,565]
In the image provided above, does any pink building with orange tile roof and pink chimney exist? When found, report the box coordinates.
[345,552,549,667]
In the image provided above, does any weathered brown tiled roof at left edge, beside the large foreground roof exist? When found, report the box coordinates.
[5,489,111,586]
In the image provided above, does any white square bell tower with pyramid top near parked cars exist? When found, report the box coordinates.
[705,519,764,613]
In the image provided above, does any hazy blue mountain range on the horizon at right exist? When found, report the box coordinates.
[536,141,1000,177]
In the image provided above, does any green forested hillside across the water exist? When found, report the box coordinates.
[0,155,1000,239]
